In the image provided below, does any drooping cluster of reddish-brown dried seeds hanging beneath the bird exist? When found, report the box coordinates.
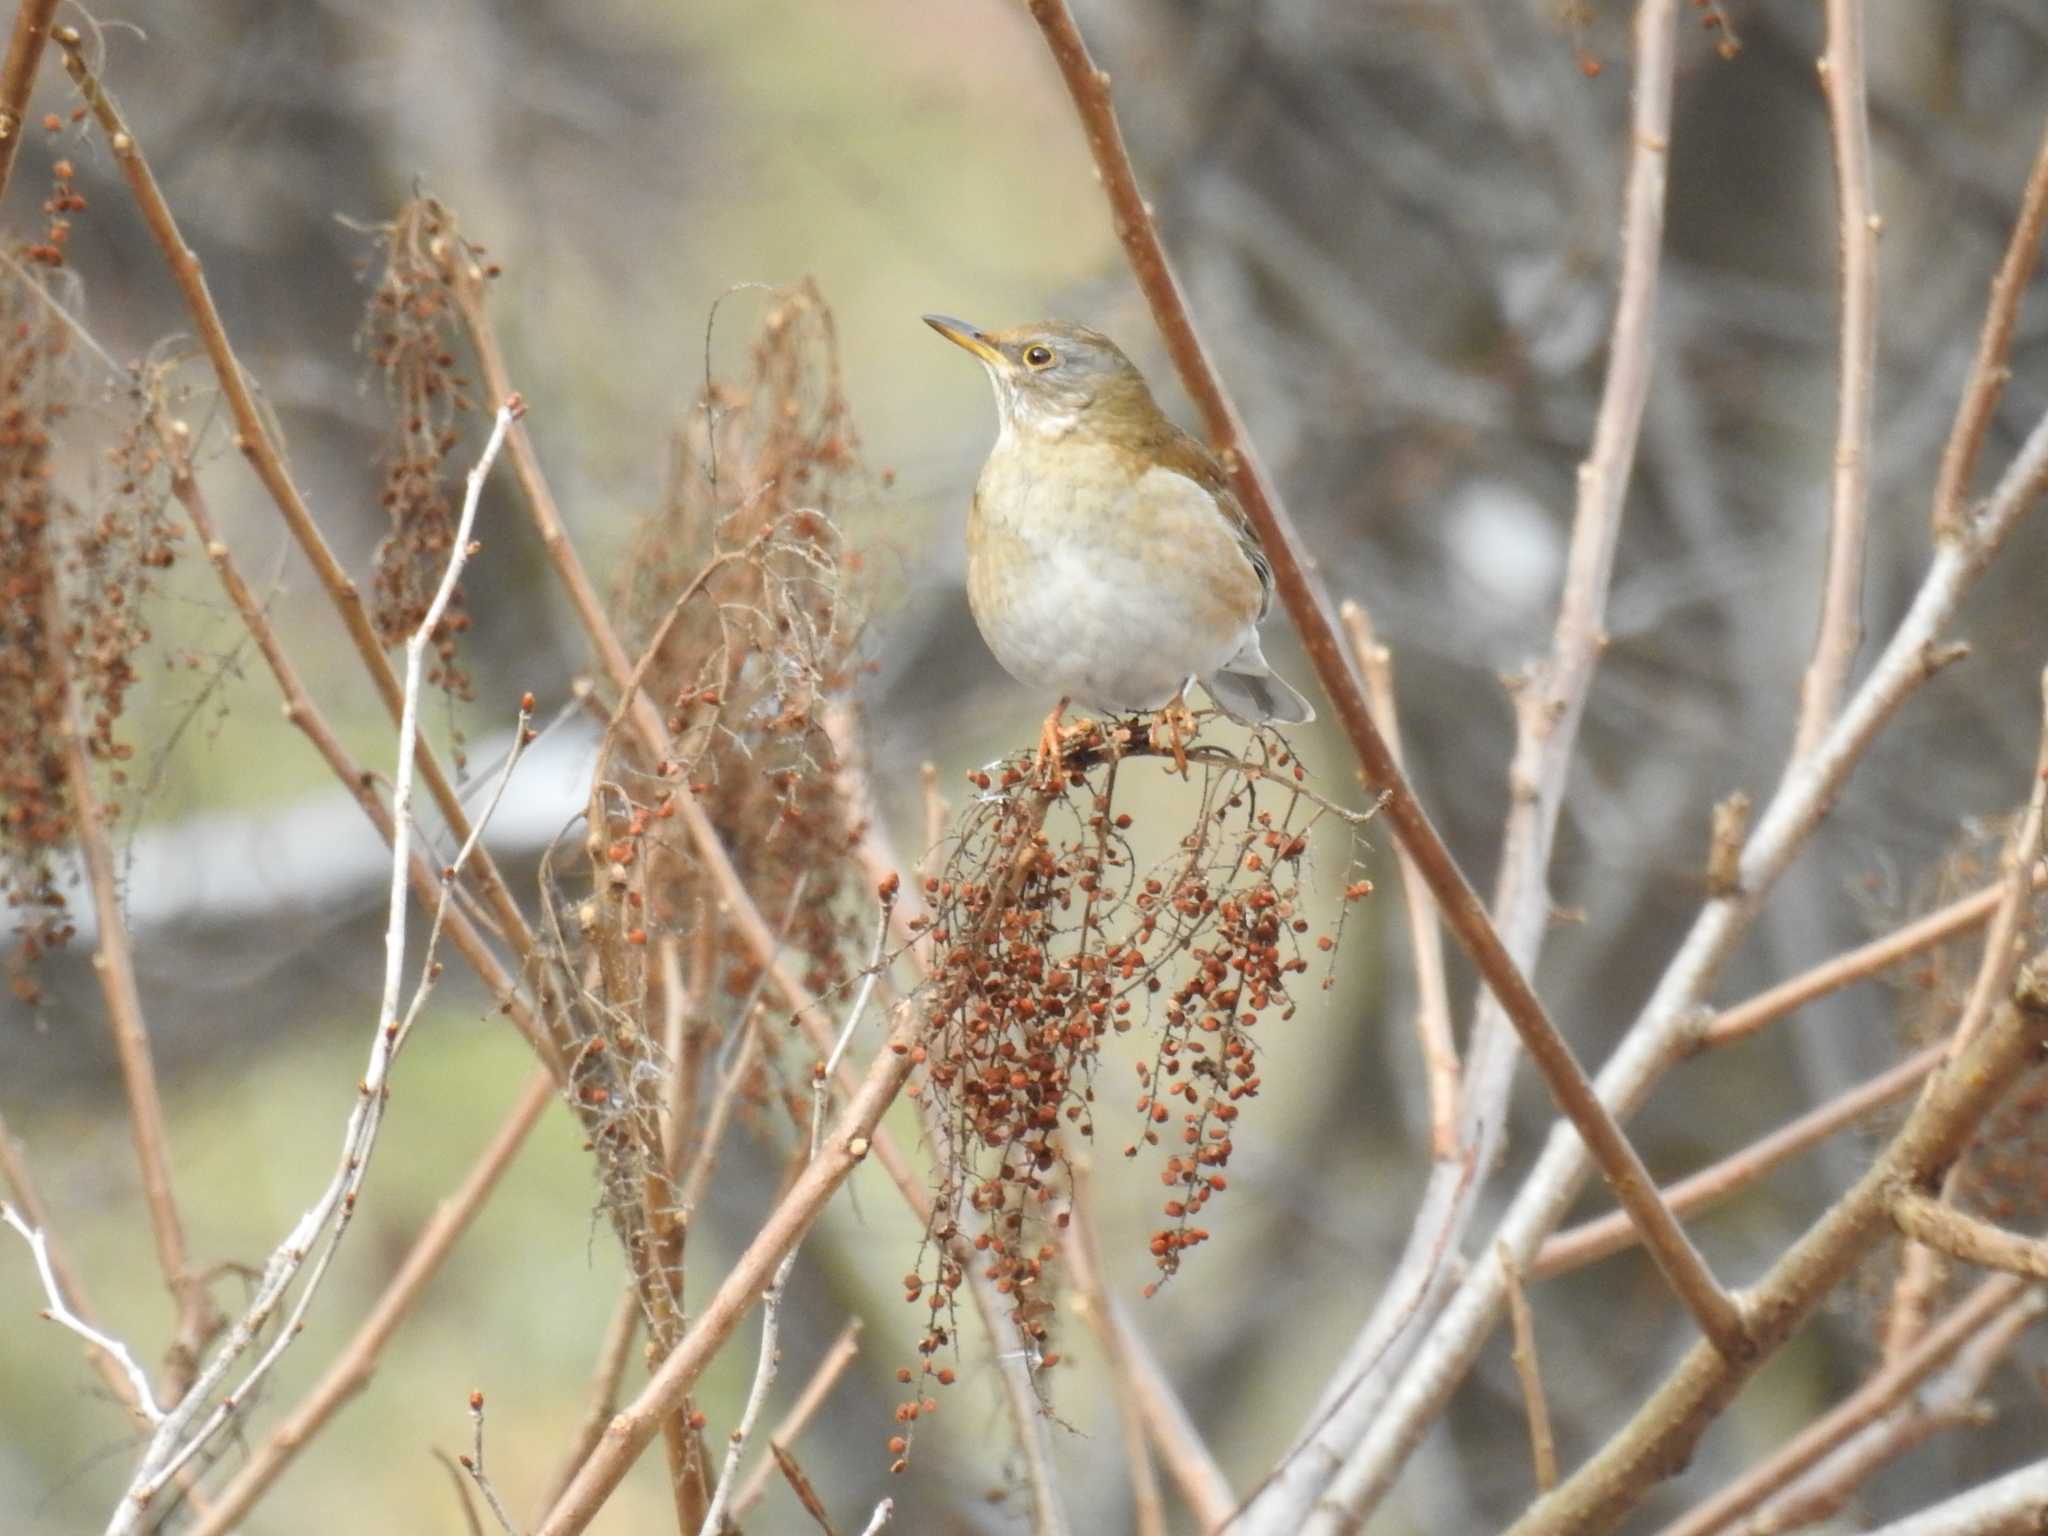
[899,731,1370,1460]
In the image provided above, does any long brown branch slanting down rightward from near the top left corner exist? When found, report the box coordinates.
[51,27,532,1003]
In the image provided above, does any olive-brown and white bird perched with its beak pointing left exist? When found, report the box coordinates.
[924,315,1315,762]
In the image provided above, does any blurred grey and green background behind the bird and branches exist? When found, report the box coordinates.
[0,0,2048,1532]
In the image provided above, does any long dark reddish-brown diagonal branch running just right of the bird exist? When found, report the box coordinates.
[1030,0,1747,1354]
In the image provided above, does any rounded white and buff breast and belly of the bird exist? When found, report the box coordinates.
[967,440,1262,711]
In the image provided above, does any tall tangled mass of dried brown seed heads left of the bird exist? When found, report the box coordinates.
[555,289,866,1343]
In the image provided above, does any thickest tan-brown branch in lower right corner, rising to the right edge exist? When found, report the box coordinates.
[1511,952,2048,1536]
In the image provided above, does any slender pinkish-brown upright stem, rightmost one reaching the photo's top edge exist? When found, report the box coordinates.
[1792,0,1878,758]
